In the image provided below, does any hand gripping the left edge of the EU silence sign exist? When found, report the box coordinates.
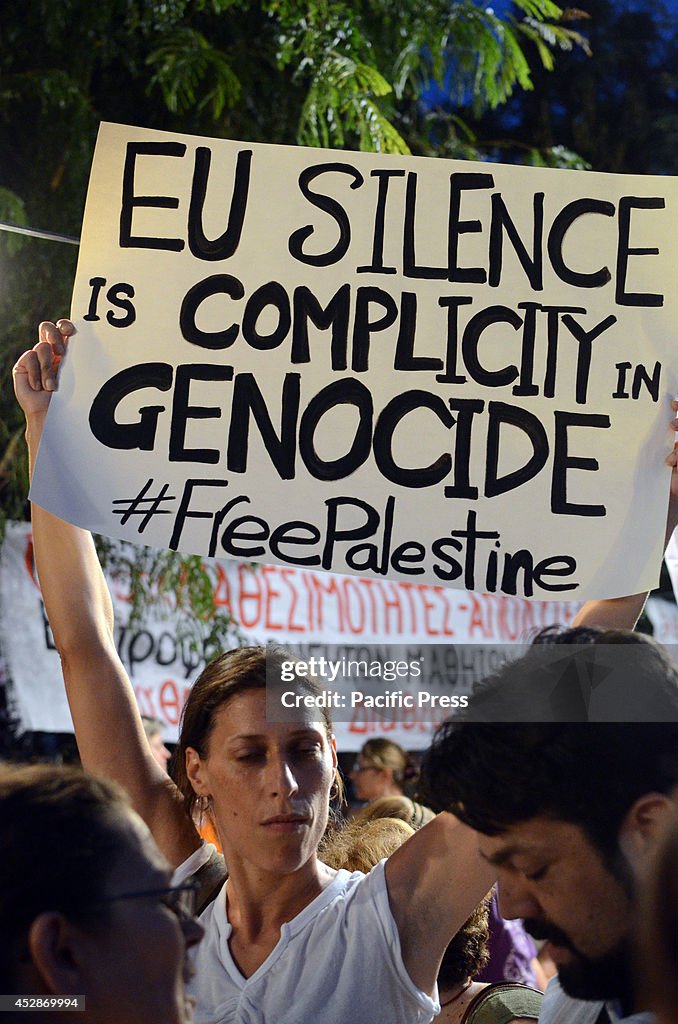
[13,319,76,420]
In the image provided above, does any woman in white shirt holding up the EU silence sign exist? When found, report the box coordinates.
[14,321,678,1024]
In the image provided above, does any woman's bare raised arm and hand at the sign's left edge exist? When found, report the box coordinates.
[14,321,200,864]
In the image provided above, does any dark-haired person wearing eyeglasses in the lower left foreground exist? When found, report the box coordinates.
[0,765,203,1024]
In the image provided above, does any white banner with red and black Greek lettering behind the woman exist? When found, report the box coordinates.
[0,523,580,751]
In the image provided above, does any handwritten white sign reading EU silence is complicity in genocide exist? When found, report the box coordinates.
[32,125,678,600]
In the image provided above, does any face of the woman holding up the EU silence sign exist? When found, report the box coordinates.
[186,689,337,874]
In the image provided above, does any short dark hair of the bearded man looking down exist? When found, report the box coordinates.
[422,629,678,858]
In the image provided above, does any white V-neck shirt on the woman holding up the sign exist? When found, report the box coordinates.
[175,848,440,1024]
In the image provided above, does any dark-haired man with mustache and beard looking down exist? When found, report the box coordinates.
[424,629,678,1024]
